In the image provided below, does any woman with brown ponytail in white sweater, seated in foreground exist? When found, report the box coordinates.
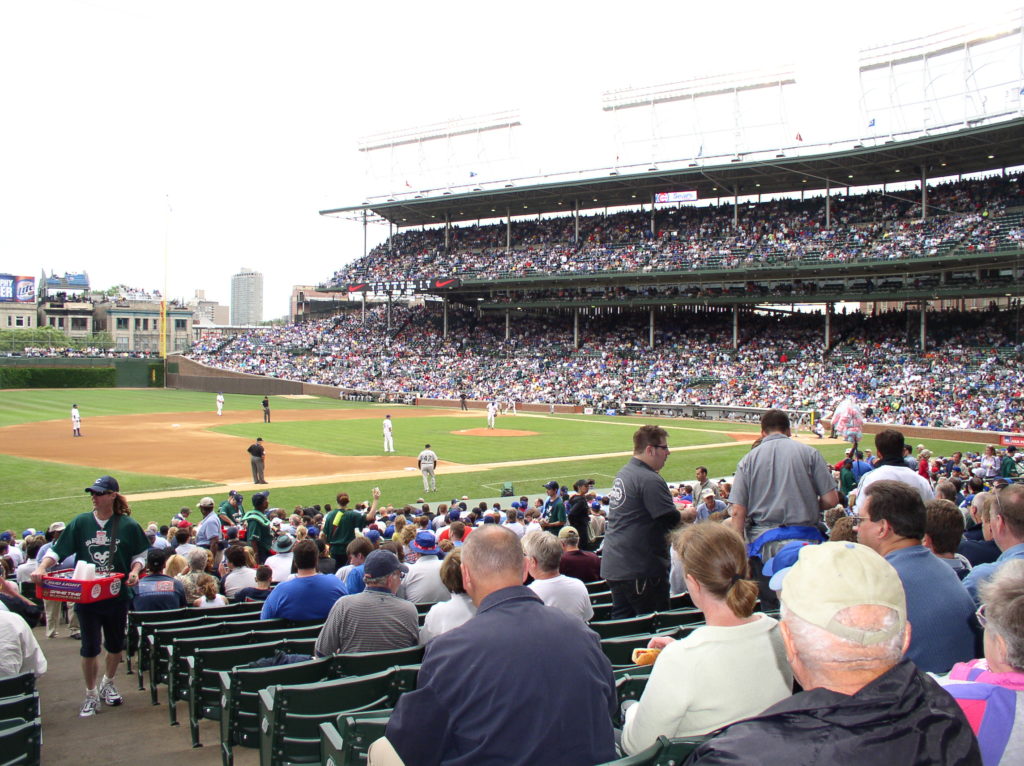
[622,521,793,755]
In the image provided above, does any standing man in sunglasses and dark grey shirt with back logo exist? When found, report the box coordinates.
[601,426,682,620]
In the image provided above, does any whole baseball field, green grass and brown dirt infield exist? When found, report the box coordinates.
[0,389,977,531]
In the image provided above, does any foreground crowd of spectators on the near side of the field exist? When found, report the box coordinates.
[6,411,1024,765]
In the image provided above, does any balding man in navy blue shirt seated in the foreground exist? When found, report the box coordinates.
[371,524,615,766]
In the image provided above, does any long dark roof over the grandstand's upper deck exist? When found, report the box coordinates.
[321,118,1024,227]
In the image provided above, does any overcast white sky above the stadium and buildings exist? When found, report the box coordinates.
[0,0,1020,318]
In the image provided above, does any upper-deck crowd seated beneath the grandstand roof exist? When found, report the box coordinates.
[330,174,1024,285]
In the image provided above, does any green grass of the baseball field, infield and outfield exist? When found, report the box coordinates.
[0,389,999,531]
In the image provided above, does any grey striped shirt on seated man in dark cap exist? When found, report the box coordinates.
[315,589,420,656]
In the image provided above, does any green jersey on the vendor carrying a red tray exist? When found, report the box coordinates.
[50,511,150,599]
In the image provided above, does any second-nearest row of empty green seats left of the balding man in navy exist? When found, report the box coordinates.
[259,666,419,766]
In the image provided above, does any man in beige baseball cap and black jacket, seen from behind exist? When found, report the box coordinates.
[687,543,981,766]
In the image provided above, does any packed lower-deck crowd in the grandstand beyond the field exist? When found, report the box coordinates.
[190,305,1024,431]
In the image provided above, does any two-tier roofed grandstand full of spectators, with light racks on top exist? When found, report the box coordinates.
[189,17,1024,430]
